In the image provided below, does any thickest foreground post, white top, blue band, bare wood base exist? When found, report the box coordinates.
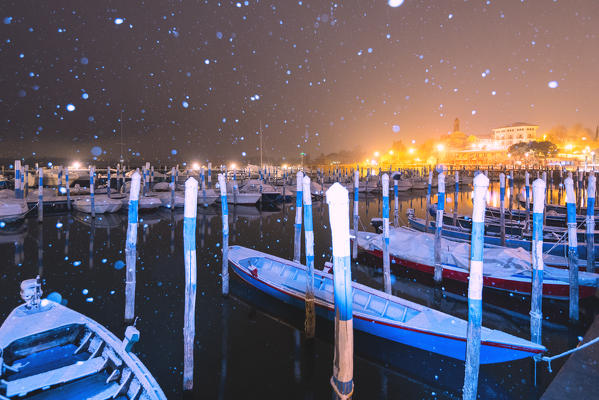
[326,183,354,400]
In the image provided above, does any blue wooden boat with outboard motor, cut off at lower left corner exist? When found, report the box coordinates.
[0,278,166,400]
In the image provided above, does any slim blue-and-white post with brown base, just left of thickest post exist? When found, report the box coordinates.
[302,175,316,338]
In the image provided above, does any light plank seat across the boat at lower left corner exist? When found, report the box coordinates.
[4,357,107,397]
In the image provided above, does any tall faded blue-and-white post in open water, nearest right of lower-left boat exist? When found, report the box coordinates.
[183,178,198,390]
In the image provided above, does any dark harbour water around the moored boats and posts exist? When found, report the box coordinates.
[0,182,597,399]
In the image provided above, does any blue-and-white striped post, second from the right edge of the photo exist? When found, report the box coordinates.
[564,177,588,322]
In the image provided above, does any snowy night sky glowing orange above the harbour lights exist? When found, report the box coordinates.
[0,0,599,162]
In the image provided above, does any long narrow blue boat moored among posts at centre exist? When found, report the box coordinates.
[229,246,546,364]
